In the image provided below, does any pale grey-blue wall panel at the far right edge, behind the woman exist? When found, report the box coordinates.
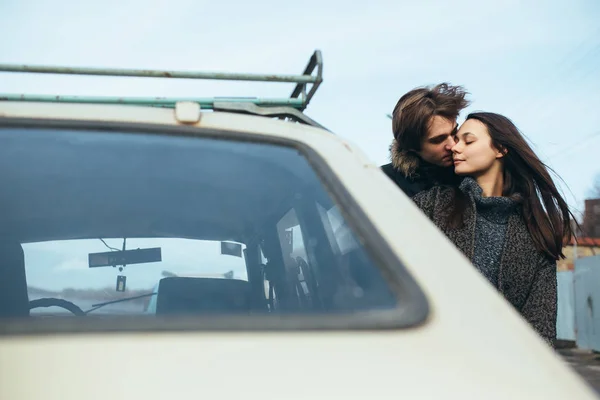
[572,256,600,351]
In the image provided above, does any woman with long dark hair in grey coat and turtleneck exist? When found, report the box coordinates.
[414,112,573,345]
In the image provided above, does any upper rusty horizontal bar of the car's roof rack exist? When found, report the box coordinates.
[0,64,319,84]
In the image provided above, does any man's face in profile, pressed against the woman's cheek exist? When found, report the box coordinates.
[418,115,457,167]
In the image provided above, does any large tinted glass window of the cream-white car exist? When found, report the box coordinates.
[0,128,398,326]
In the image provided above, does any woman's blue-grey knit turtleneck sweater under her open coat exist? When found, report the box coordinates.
[460,178,518,288]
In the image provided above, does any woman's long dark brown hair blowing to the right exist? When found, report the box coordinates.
[449,112,575,260]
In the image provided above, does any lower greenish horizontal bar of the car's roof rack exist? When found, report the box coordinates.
[0,93,304,110]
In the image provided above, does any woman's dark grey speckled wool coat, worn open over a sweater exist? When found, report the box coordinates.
[413,178,557,346]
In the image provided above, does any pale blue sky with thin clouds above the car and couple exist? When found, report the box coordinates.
[0,0,600,220]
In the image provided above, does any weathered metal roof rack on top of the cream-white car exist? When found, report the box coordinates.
[0,50,325,129]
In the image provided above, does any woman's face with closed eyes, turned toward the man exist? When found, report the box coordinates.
[452,119,503,176]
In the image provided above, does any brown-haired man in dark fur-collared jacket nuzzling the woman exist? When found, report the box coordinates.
[381,83,469,197]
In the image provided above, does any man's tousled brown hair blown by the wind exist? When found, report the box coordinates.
[391,83,469,176]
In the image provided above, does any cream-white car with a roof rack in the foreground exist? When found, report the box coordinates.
[0,52,596,400]
